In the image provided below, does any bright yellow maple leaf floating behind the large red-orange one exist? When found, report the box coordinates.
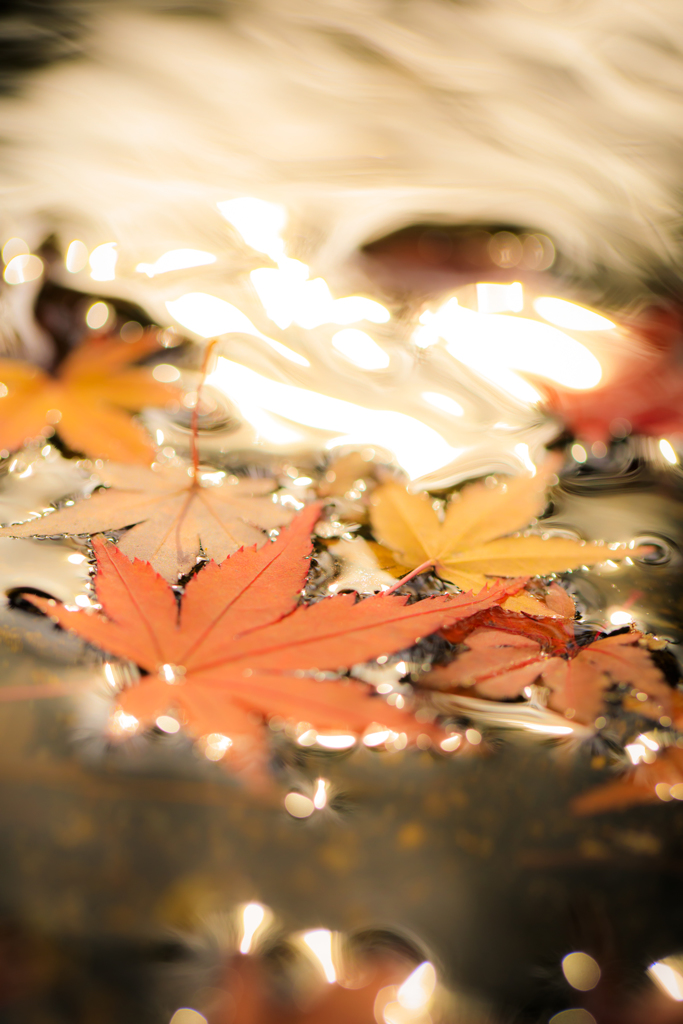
[371,459,633,598]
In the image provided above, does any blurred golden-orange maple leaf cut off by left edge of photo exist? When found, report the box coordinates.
[0,332,178,463]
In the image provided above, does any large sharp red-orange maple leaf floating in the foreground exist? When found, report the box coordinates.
[25,506,518,774]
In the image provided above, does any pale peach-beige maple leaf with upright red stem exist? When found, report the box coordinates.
[0,463,293,583]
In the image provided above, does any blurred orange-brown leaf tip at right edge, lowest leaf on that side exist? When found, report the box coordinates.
[571,746,683,814]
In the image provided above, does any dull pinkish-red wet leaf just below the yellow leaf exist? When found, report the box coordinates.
[421,629,672,725]
